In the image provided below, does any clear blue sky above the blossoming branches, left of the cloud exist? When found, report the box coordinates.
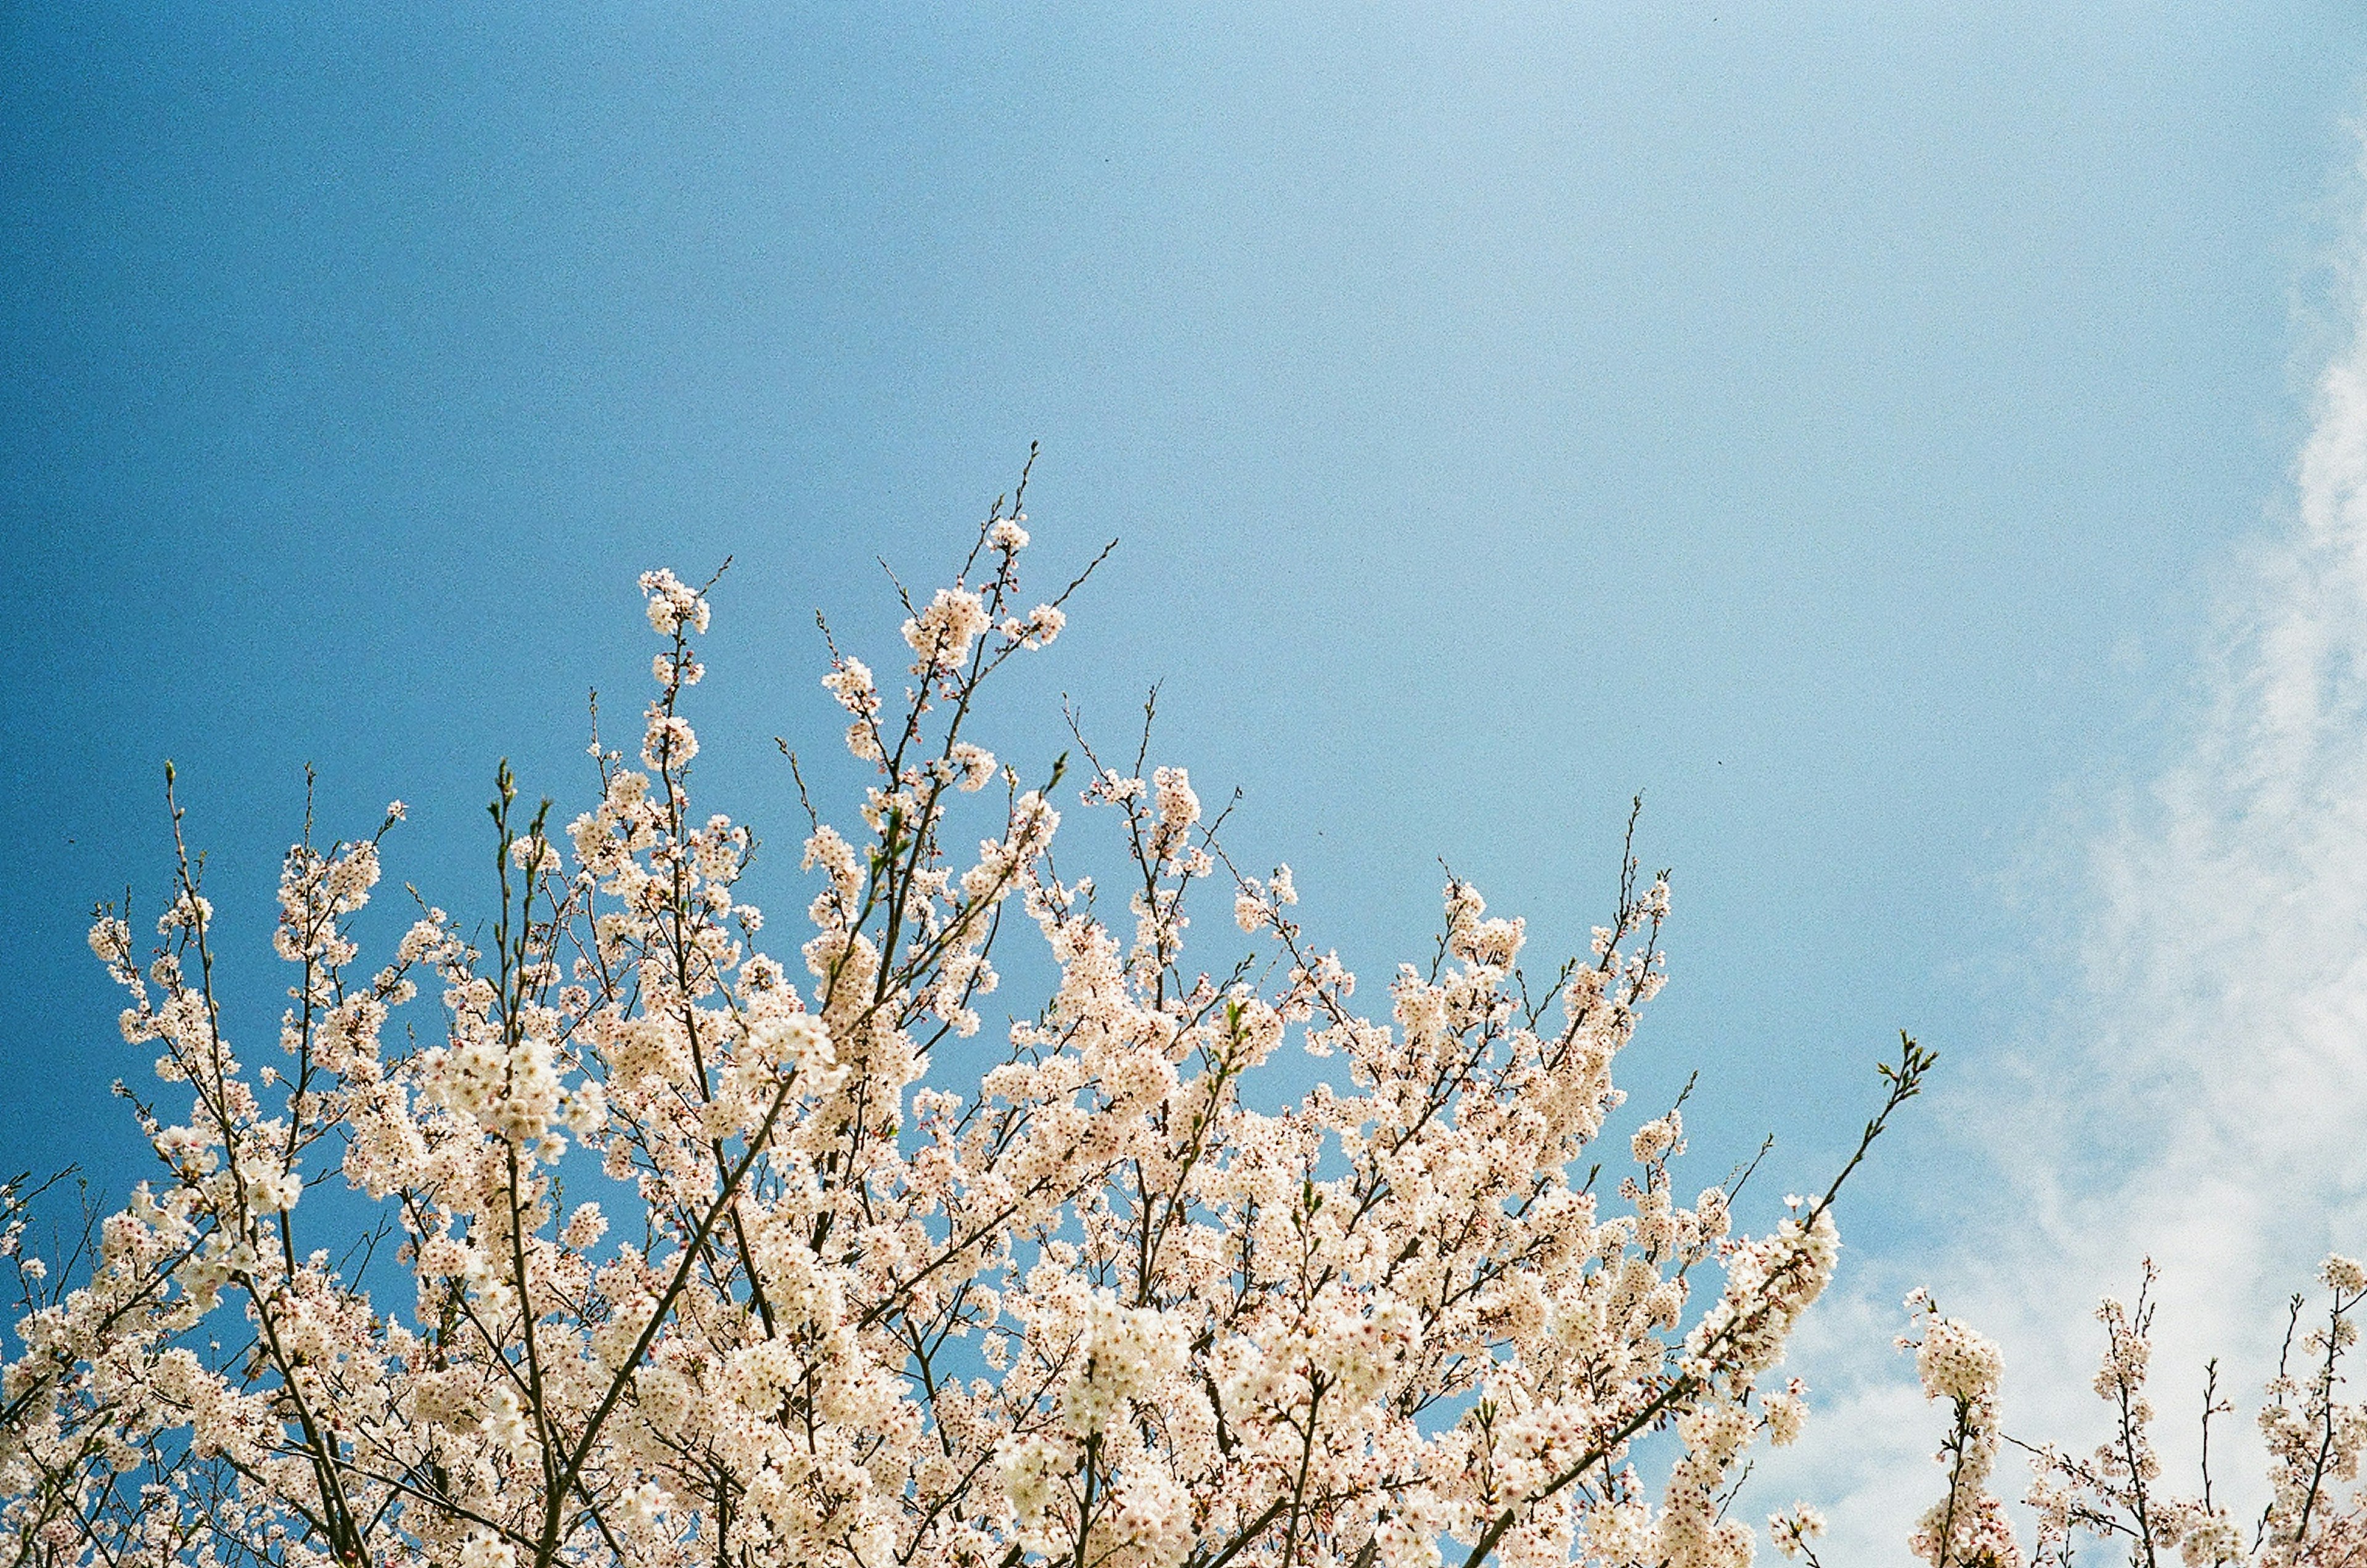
[0,0,2367,1544]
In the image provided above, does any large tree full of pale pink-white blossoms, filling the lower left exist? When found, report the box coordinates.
[0,486,1931,1568]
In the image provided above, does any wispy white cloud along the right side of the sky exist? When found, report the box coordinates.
[1759,141,2367,1563]
